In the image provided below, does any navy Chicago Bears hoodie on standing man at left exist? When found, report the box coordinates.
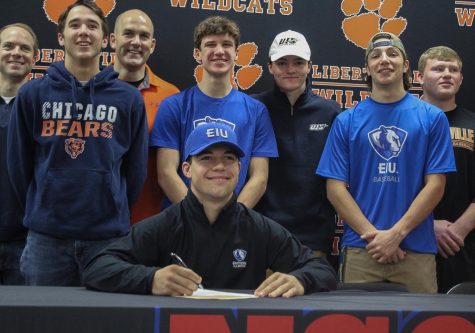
[7,62,148,240]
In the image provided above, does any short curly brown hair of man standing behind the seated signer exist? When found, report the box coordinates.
[193,16,241,49]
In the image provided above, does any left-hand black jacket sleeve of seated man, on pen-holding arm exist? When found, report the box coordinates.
[83,215,166,294]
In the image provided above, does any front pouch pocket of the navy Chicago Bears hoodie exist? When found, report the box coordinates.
[41,169,118,229]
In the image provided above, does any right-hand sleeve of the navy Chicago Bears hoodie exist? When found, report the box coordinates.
[122,96,148,207]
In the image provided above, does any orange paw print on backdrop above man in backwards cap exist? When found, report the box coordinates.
[341,0,407,49]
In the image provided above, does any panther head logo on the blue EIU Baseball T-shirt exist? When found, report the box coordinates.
[368,125,407,161]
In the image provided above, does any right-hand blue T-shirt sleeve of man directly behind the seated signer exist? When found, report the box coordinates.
[251,102,279,157]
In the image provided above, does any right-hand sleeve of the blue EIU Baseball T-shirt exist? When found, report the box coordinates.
[425,111,456,175]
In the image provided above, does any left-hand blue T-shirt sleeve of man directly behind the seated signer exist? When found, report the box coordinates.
[150,96,181,151]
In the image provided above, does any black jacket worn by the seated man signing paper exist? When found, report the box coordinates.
[83,191,336,294]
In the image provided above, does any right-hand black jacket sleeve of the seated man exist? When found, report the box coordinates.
[265,218,336,294]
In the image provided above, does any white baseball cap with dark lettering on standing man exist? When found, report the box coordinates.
[269,30,311,61]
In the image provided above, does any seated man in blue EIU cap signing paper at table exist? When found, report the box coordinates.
[84,123,336,297]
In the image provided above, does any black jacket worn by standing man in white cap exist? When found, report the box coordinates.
[253,82,340,253]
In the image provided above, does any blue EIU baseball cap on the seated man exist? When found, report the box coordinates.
[184,123,244,160]
